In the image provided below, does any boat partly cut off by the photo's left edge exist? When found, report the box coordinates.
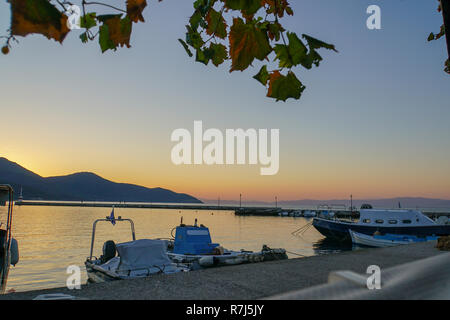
[0,185,19,293]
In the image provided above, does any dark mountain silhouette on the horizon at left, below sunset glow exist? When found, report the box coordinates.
[0,158,201,203]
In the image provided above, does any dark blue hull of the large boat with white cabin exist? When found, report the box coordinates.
[313,218,450,241]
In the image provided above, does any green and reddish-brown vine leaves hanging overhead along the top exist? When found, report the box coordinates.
[2,0,337,101]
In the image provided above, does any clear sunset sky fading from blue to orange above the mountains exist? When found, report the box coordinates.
[0,0,450,201]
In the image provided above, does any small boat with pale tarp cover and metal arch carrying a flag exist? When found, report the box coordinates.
[85,210,189,282]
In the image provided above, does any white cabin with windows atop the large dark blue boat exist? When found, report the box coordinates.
[358,210,436,227]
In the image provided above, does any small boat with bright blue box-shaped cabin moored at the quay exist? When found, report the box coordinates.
[168,219,288,268]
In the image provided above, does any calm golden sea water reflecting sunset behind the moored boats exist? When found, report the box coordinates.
[0,206,351,291]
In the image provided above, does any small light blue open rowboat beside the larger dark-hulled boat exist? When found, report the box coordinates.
[349,230,438,247]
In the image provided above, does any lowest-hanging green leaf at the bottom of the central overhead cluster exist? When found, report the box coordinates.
[267,71,305,101]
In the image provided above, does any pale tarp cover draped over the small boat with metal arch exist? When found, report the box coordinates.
[116,239,172,271]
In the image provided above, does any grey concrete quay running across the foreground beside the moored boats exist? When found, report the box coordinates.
[0,241,449,300]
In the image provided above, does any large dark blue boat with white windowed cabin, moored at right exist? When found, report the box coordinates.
[313,209,450,241]
